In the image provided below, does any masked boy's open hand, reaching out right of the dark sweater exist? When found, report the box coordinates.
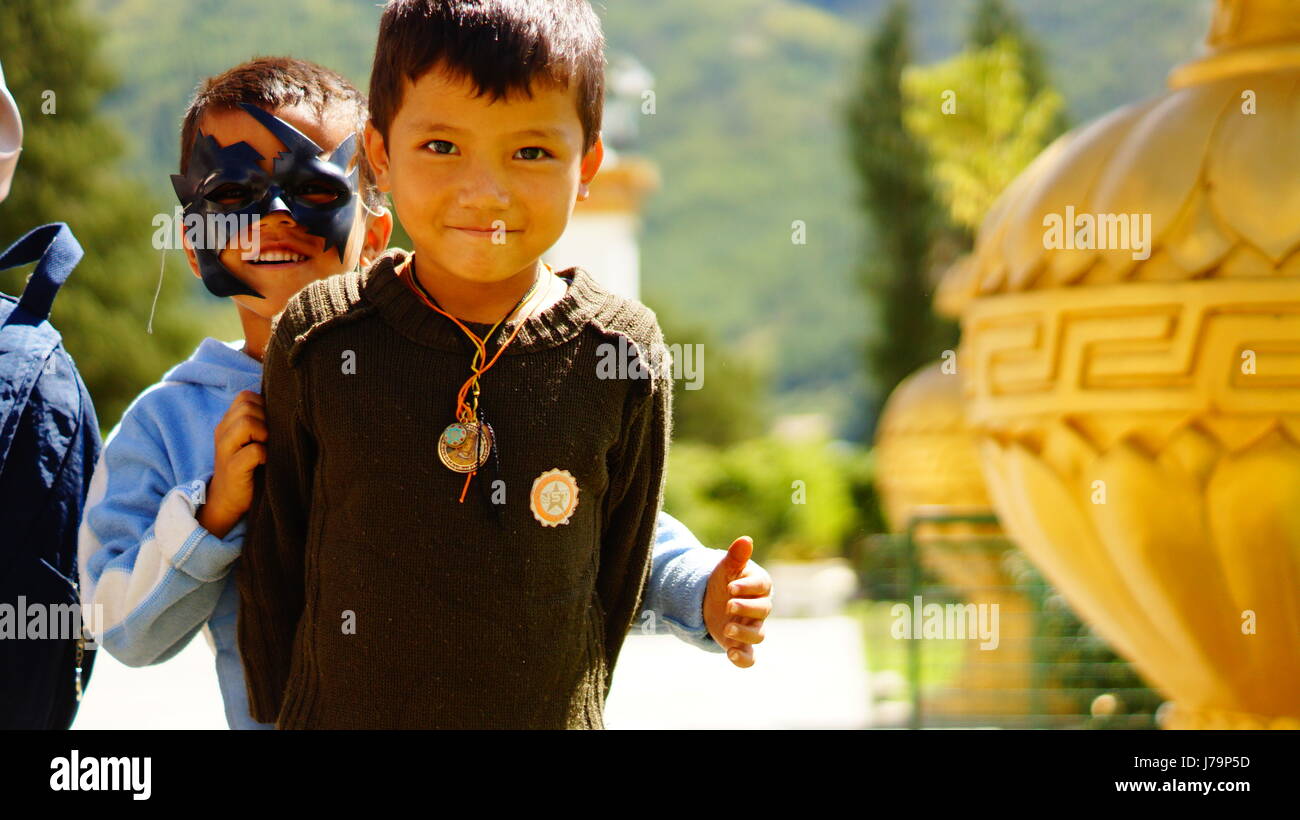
[705,535,772,669]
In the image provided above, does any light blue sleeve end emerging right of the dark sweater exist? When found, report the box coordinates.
[633,512,727,652]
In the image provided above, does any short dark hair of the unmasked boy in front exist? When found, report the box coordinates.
[371,0,605,153]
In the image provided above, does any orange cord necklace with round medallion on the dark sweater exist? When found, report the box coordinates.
[395,253,554,503]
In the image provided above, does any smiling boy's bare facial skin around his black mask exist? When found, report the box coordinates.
[186,107,387,320]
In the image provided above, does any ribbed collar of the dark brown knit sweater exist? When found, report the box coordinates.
[361,248,608,356]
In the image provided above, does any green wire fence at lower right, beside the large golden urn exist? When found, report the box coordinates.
[855,508,1162,729]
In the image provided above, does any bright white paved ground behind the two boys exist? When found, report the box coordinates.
[74,616,868,729]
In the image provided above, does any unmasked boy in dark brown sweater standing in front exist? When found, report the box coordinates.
[239,0,761,728]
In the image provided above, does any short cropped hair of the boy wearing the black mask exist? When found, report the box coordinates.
[181,57,384,209]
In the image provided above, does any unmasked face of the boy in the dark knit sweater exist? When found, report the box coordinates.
[365,66,603,283]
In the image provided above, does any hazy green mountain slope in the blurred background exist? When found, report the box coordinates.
[87,0,1208,435]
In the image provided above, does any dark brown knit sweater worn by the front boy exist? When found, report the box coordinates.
[238,251,672,729]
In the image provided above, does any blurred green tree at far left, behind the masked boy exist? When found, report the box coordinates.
[0,0,212,429]
